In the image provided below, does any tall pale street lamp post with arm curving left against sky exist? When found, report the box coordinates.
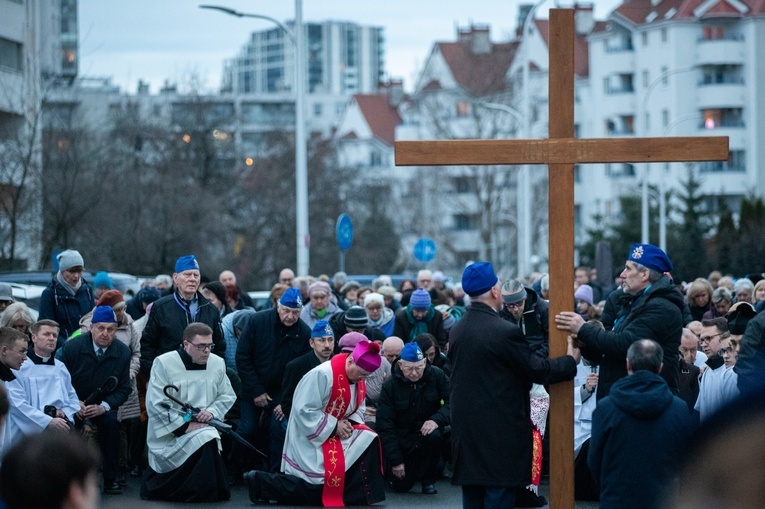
[199,0,311,276]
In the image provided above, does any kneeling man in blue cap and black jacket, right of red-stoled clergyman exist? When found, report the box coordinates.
[375,343,451,495]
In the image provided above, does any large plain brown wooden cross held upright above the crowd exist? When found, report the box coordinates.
[395,9,728,509]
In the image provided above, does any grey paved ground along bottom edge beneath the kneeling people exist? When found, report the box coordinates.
[102,479,598,509]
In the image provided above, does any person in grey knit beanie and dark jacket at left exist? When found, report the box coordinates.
[38,249,95,347]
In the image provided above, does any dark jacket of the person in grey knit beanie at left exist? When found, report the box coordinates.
[38,276,95,347]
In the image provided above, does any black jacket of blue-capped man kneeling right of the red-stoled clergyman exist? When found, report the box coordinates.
[375,363,451,466]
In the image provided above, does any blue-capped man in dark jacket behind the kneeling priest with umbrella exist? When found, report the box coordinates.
[141,255,226,376]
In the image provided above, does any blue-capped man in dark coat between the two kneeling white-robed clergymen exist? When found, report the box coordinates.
[236,288,311,466]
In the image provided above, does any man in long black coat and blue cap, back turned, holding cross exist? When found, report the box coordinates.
[448,262,579,507]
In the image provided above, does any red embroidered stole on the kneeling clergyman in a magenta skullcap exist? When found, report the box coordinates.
[321,354,367,507]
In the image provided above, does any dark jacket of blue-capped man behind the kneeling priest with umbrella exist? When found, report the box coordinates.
[141,292,226,377]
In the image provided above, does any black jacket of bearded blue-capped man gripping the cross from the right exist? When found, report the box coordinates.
[578,276,685,400]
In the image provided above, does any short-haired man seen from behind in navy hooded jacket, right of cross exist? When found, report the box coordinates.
[587,339,692,509]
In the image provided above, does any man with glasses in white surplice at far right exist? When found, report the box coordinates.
[694,317,739,422]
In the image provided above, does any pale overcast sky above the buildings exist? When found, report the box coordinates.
[78,0,619,93]
